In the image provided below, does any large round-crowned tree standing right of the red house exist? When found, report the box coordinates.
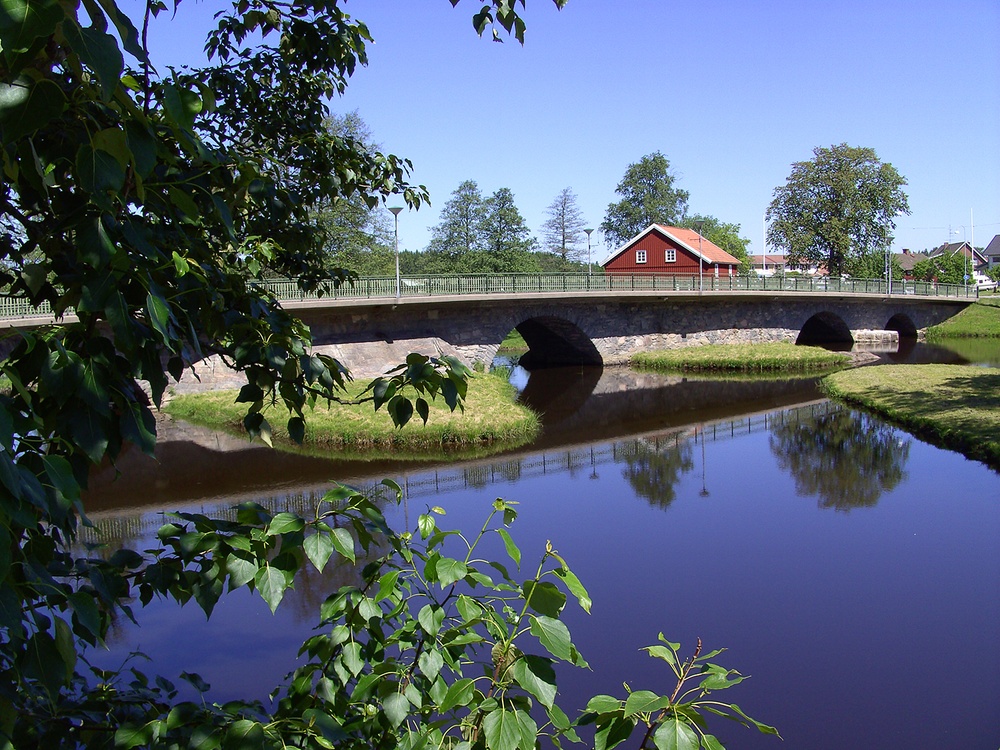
[767,143,910,276]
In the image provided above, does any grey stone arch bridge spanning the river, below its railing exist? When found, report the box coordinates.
[223,291,972,384]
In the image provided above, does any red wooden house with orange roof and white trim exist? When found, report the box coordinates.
[601,224,740,276]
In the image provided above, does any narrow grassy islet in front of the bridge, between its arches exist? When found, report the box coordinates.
[631,341,850,372]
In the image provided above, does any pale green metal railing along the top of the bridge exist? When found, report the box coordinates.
[0,273,979,320]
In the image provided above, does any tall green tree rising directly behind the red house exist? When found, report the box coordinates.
[601,151,689,247]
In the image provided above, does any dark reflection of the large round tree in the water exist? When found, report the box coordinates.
[770,409,911,511]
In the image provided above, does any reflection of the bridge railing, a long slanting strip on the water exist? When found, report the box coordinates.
[80,400,844,546]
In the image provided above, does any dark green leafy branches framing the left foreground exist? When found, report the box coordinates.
[0,0,776,750]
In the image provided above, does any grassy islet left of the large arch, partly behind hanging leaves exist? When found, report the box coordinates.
[165,374,540,460]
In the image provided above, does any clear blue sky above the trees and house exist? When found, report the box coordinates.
[150,0,1000,260]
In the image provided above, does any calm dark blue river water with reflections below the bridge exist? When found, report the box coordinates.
[82,347,1000,750]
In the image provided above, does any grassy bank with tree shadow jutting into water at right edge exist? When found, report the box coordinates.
[821,365,1000,470]
